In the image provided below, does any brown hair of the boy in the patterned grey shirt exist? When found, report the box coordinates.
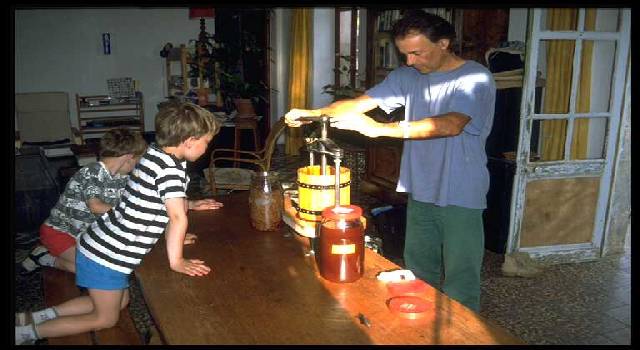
[100,128,147,158]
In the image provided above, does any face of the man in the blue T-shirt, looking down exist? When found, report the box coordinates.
[395,34,449,73]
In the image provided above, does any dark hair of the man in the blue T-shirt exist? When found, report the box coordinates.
[391,10,456,48]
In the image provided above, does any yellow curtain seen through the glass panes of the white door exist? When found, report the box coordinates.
[541,9,596,161]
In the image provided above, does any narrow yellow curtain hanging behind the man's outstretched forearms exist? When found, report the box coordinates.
[285,8,313,155]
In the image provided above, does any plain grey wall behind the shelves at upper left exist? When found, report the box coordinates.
[15,8,202,130]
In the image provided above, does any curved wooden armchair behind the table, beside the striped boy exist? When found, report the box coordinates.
[205,117,286,194]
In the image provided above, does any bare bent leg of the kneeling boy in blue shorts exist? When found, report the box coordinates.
[36,289,128,338]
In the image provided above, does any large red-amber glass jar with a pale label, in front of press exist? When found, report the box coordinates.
[317,205,364,283]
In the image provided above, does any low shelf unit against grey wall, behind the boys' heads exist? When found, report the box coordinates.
[76,92,144,143]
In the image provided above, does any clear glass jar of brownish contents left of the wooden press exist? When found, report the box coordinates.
[249,171,284,231]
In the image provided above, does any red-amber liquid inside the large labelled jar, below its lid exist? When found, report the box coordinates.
[318,220,364,282]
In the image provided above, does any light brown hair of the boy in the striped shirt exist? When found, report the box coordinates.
[156,102,220,147]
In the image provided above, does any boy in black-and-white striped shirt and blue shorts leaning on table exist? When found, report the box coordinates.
[15,103,220,344]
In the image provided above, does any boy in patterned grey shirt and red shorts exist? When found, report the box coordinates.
[22,128,147,273]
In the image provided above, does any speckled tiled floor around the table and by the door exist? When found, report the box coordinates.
[15,145,631,345]
